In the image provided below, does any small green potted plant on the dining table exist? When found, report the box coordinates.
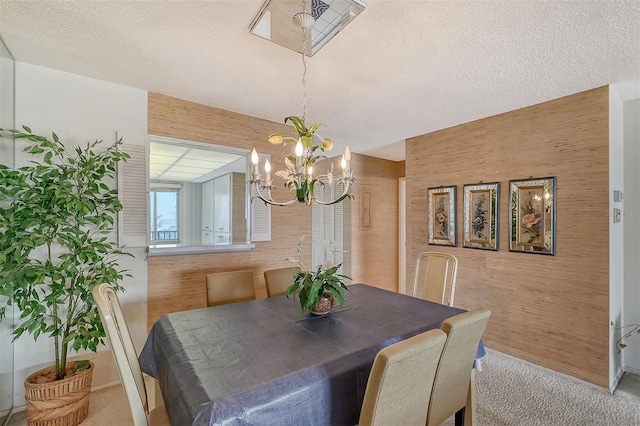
[287,236,351,315]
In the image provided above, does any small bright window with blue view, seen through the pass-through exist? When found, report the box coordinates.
[149,188,180,244]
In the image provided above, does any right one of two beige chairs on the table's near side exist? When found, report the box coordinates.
[427,308,491,426]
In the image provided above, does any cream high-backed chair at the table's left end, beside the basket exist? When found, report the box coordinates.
[92,284,171,426]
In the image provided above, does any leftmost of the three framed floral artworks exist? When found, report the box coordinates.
[427,186,458,247]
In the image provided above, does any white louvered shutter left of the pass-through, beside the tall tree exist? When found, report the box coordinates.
[117,133,149,247]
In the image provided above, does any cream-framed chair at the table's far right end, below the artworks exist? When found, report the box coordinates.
[413,251,458,306]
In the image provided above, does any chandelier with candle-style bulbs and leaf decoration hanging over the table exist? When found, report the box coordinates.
[250,1,356,206]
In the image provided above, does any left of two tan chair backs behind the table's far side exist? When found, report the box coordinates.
[207,270,256,306]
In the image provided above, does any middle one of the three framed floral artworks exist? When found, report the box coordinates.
[462,182,500,251]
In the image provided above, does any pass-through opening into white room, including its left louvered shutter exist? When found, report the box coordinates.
[118,133,270,255]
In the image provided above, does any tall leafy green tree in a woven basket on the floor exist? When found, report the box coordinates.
[0,126,130,425]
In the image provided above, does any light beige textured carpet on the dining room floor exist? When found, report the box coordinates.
[9,349,640,426]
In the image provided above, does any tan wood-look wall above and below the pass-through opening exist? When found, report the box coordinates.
[148,93,311,328]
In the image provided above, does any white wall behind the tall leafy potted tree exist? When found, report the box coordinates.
[14,62,147,406]
